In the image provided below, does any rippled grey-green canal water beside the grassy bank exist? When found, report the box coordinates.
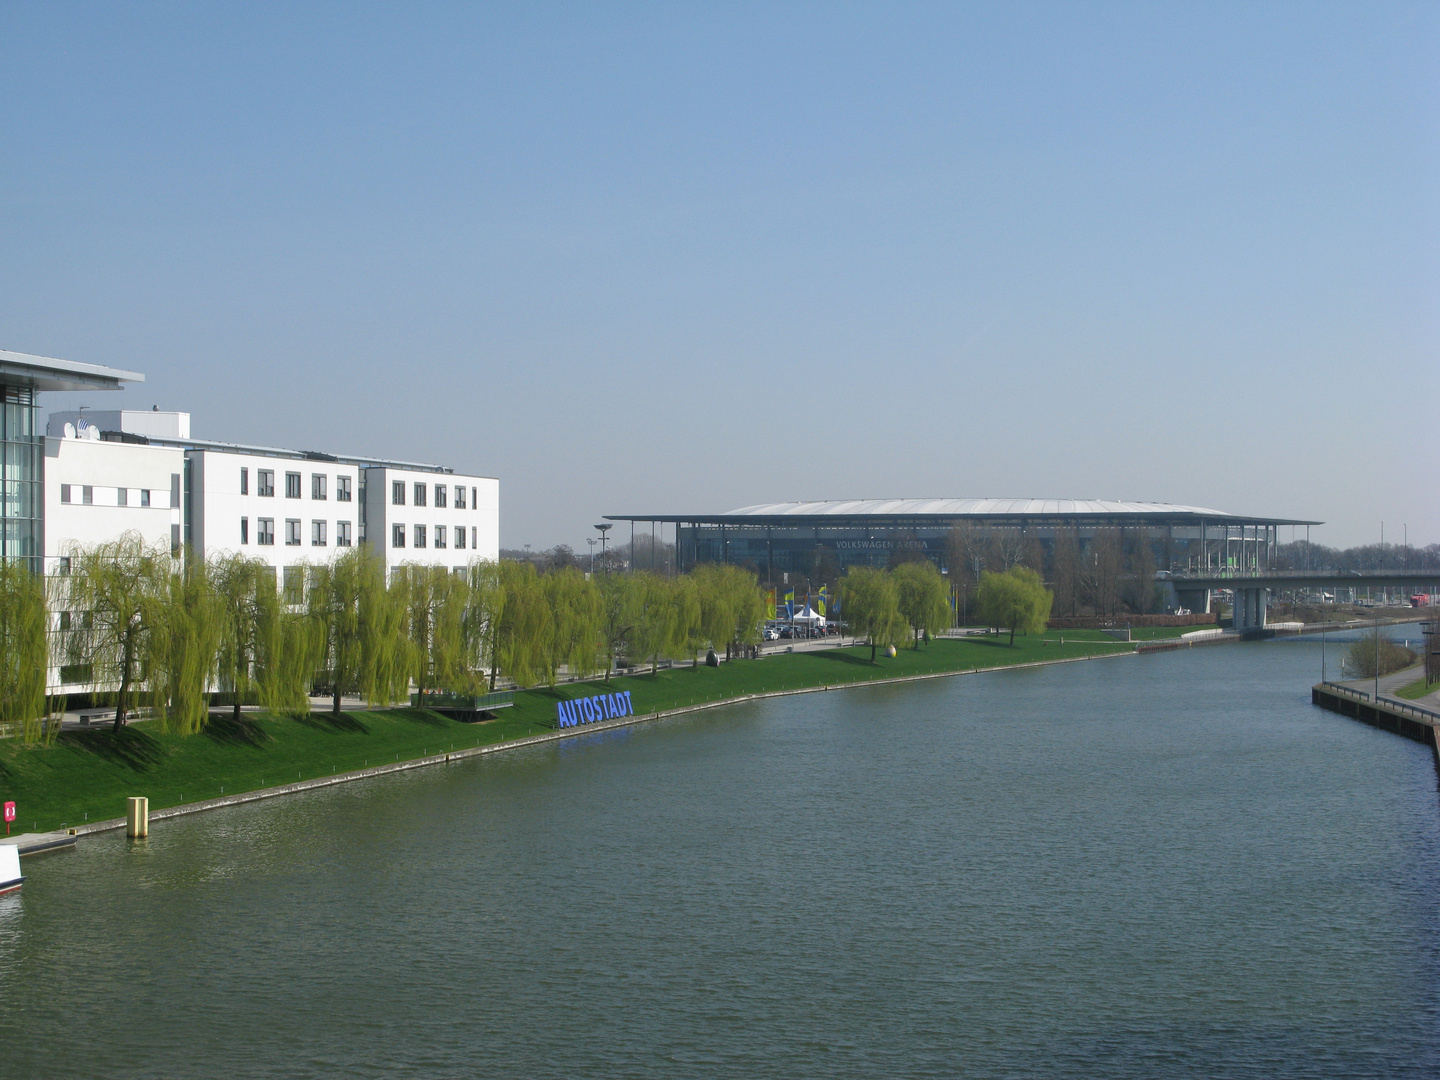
[0,642,1440,1080]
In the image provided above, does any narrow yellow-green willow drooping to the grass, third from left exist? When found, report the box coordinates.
[153,557,220,734]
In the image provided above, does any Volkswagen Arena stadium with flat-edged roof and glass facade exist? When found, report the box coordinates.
[606,498,1319,580]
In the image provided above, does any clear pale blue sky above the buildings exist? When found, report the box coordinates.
[0,3,1440,549]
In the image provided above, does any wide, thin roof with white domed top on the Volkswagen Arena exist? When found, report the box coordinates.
[606,498,1320,526]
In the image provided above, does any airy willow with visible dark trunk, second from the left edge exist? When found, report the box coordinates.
[60,533,173,732]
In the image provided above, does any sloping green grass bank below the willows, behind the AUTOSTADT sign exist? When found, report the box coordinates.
[0,631,1129,832]
